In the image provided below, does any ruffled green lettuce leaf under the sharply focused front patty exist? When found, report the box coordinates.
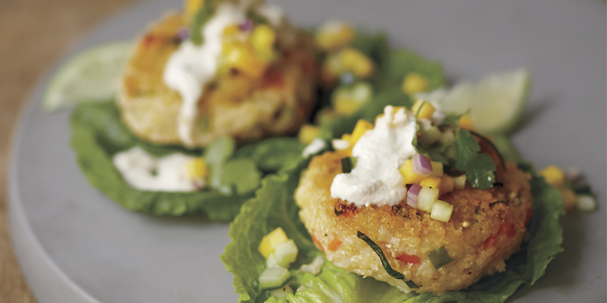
[221,156,563,303]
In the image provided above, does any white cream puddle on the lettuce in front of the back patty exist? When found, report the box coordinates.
[113,147,204,192]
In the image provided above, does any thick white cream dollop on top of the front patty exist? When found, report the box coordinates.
[331,106,416,206]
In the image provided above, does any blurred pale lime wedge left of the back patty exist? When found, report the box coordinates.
[42,42,133,111]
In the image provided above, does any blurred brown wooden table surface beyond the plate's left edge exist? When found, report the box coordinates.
[0,0,135,303]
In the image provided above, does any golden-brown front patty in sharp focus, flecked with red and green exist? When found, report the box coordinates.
[295,152,532,293]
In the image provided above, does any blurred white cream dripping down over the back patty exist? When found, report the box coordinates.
[162,1,248,146]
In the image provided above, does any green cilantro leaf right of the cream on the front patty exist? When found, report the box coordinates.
[455,129,496,189]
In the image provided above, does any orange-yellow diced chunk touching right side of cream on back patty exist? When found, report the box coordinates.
[222,43,266,78]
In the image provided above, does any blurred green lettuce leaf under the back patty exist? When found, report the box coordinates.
[71,101,304,221]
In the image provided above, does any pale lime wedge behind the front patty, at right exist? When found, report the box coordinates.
[416,69,531,134]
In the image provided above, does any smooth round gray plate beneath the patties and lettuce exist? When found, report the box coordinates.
[9,0,607,303]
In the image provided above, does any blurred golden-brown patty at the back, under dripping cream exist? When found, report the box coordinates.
[118,13,316,146]
